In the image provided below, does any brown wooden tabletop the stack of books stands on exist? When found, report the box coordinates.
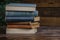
[0,26,60,40]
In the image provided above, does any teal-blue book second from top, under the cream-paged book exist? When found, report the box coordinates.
[6,11,38,17]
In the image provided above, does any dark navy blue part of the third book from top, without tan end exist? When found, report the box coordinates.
[5,17,34,22]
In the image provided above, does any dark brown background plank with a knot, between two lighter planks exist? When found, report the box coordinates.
[37,7,60,17]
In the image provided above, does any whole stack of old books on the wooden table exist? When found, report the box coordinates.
[5,3,40,34]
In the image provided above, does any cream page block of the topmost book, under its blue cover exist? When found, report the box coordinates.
[6,6,36,11]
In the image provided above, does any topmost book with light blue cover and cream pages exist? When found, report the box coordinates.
[6,3,36,11]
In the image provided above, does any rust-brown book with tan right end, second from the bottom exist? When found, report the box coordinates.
[7,23,40,29]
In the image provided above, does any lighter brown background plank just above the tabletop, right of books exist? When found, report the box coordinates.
[40,17,60,26]
